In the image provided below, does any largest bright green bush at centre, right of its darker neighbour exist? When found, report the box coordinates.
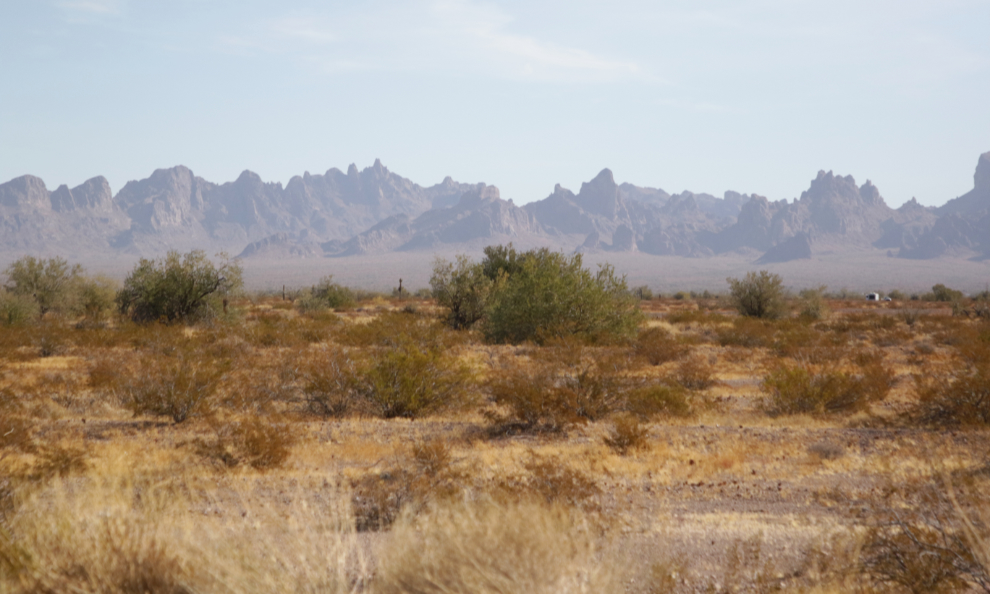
[483,249,641,343]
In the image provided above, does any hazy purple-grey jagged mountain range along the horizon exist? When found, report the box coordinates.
[0,152,990,263]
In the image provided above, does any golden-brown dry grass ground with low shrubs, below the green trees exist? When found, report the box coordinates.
[0,299,990,592]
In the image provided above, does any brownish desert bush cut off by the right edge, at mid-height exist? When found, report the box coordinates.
[910,360,990,427]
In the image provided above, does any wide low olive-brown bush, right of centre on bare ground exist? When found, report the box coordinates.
[761,354,893,414]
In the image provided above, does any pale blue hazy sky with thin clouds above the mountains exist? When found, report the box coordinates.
[0,0,990,206]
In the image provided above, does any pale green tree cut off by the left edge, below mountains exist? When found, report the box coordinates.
[4,256,82,315]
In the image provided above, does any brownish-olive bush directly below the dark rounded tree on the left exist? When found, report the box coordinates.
[120,347,229,423]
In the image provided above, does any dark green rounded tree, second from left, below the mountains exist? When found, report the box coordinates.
[117,250,243,322]
